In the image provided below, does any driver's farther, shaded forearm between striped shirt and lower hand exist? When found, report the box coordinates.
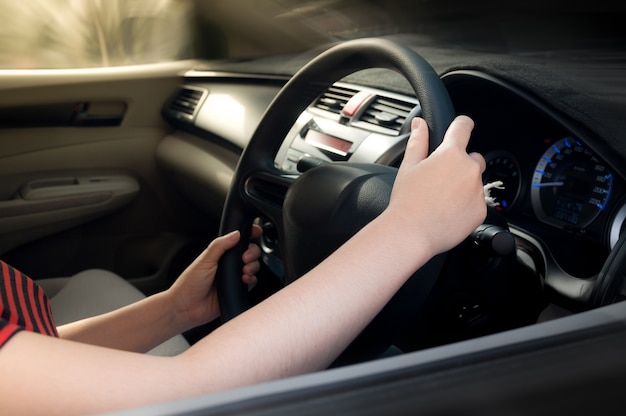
[58,292,188,352]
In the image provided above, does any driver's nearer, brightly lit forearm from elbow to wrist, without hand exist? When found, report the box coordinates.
[180,211,432,394]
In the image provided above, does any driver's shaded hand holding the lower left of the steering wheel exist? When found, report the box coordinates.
[168,225,263,329]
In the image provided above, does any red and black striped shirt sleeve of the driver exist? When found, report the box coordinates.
[0,260,59,347]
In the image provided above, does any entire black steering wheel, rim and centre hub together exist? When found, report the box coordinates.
[216,38,455,322]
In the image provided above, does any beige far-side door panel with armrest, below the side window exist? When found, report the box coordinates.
[0,62,217,292]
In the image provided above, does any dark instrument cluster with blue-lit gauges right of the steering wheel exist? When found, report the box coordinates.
[447,74,626,279]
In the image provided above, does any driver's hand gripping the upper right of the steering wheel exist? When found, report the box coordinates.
[388,116,487,255]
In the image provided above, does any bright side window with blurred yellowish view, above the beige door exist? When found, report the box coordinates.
[0,0,192,69]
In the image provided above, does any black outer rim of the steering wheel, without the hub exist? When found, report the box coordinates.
[216,38,455,322]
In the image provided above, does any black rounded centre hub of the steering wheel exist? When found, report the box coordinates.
[283,163,397,282]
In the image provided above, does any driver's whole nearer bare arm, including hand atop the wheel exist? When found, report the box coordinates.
[0,117,486,414]
